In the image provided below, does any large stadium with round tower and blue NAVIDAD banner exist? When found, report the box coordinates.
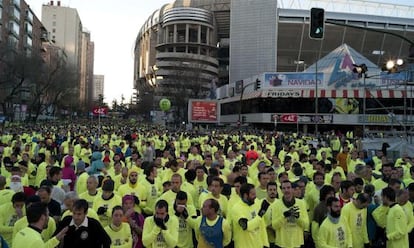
[134,0,414,136]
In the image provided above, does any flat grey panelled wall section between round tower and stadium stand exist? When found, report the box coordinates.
[229,0,277,82]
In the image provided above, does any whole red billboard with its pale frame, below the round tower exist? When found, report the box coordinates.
[188,99,220,123]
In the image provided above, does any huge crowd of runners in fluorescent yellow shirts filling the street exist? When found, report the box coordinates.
[0,120,414,248]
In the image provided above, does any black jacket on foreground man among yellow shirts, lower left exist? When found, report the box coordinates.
[55,216,111,248]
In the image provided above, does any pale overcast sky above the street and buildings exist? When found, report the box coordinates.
[26,0,414,104]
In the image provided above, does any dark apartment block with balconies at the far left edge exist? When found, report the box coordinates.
[0,0,56,119]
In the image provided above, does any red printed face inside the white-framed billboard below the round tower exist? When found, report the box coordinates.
[191,101,217,122]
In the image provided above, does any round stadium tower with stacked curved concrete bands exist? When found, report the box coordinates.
[134,0,230,120]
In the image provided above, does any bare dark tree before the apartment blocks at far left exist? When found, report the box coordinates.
[0,42,77,121]
